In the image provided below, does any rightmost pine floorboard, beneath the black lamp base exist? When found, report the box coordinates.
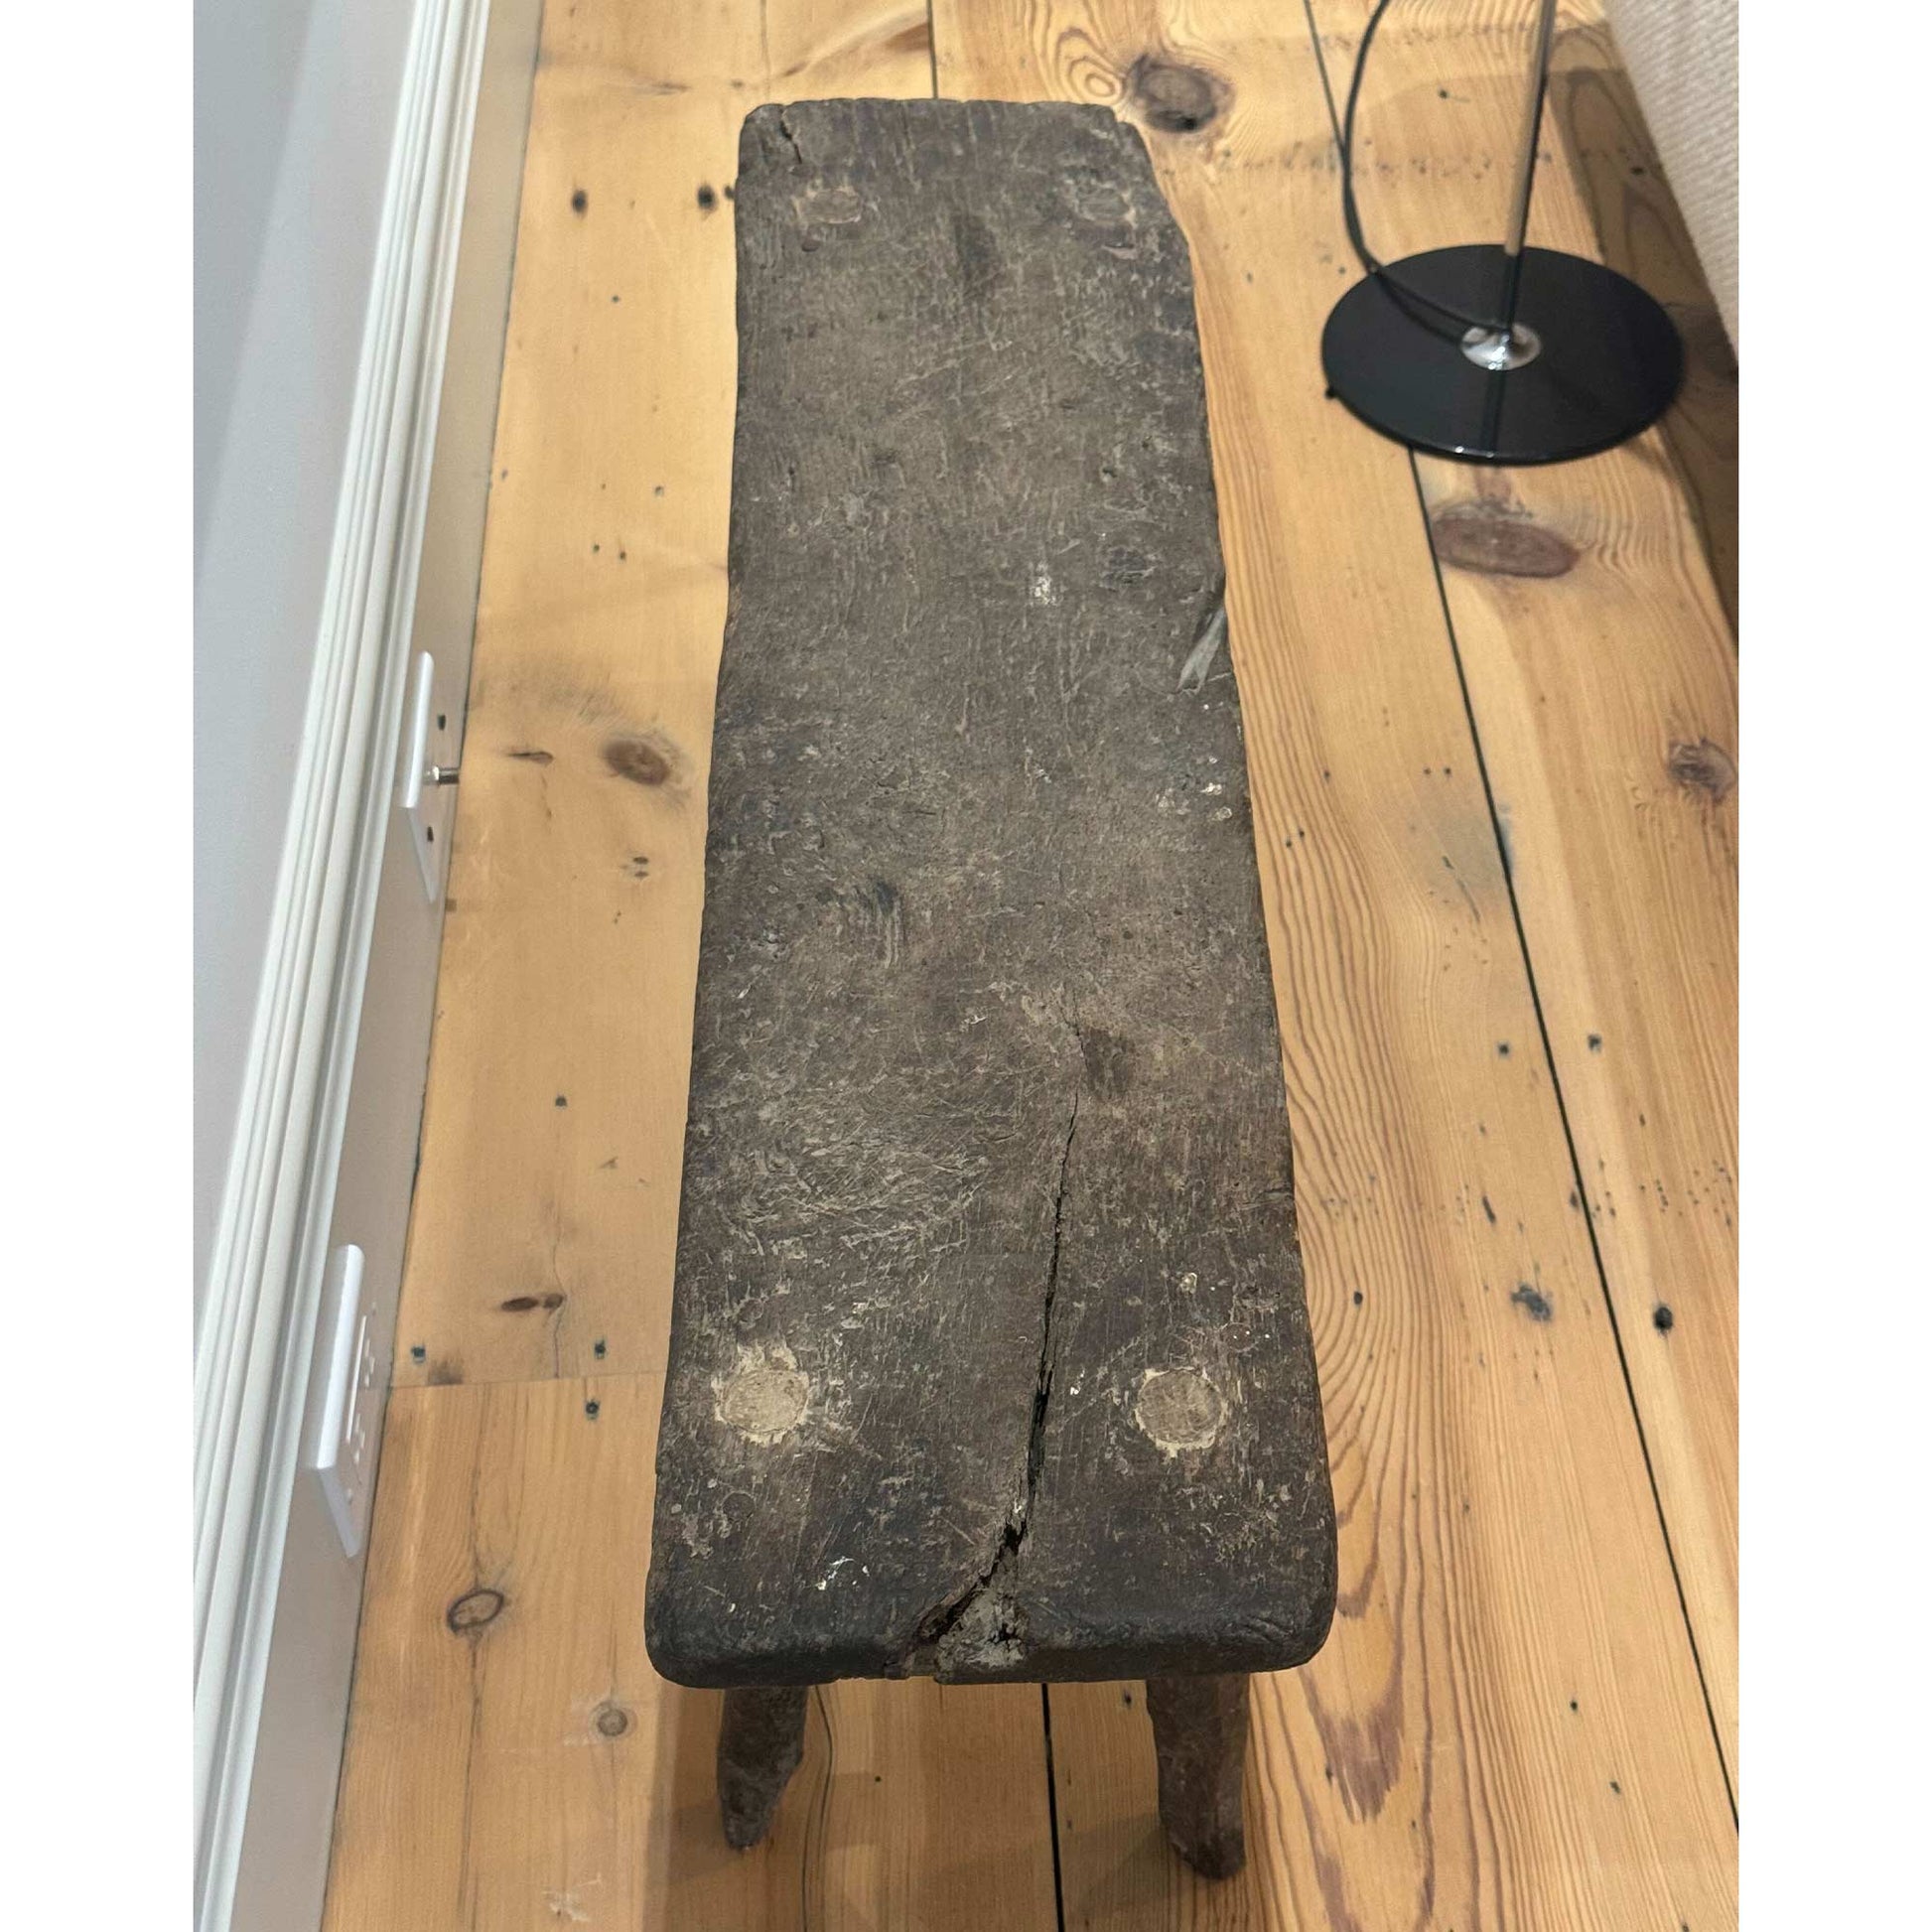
[1313,0,1736,1781]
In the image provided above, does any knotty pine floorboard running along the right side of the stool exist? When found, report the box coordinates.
[937,0,1735,1932]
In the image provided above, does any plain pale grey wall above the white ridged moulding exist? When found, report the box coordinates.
[196,0,415,1317]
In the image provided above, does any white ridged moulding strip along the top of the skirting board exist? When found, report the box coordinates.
[196,0,488,1932]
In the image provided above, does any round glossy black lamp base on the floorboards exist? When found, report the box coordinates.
[1321,243,1685,464]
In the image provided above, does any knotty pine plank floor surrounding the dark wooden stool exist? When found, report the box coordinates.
[317,0,1736,1932]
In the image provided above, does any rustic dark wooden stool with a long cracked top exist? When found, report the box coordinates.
[647,100,1335,1874]
